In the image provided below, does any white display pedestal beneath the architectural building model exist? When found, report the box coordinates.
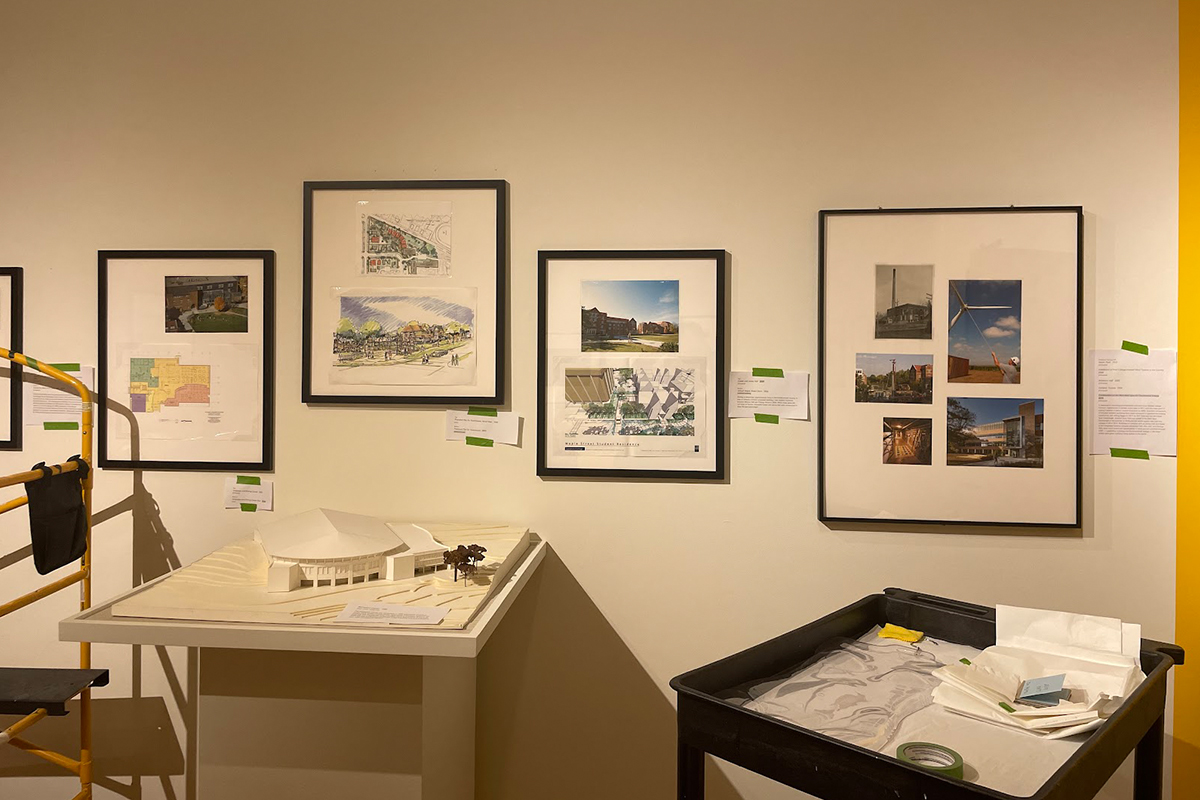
[59,539,546,800]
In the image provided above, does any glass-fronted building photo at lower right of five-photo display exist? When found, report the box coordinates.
[946,397,1045,468]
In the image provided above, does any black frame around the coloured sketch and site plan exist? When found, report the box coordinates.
[300,180,509,405]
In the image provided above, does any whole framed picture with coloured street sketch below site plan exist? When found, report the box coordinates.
[302,180,509,405]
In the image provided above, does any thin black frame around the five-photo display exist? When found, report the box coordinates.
[817,205,1084,530]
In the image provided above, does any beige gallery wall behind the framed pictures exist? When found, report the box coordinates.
[0,0,1177,800]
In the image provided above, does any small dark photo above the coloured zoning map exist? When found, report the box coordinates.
[163,275,250,333]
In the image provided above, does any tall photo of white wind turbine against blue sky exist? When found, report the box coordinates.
[946,281,1021,384]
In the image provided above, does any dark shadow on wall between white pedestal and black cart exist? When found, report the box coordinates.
[475,549,742,800]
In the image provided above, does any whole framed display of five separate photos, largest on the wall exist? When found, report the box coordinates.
[818,206,1084,528]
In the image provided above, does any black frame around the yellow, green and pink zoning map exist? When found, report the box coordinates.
[96,249,275,473]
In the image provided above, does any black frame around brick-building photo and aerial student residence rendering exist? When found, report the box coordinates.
[538,249,730,482]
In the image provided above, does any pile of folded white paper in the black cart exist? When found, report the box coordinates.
[934,606,1145,739]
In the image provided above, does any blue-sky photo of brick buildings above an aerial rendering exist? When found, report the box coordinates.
[580,281,679,353]
